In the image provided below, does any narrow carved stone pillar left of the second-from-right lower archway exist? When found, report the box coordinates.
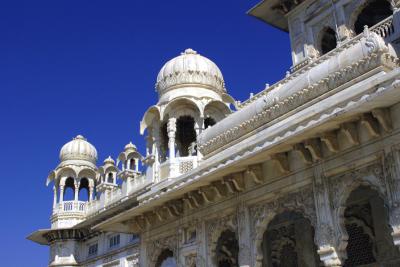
[237,203,252,267]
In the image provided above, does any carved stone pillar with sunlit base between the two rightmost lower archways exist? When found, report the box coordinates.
[313,165,344,267]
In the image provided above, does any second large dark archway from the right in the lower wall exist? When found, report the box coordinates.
[261,211,323,267]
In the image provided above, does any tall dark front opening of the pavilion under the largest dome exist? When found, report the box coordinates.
[176,116,196,157]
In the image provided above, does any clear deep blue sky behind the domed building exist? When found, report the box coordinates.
[0,0,291,267]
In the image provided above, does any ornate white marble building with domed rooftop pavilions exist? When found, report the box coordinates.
[28,0,400,267]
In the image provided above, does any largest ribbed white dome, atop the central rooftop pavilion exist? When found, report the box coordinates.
[156,48,226,95]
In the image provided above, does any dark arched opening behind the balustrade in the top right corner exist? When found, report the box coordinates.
[354,0,393,34]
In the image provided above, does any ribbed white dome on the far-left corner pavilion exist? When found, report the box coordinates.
[60,135,97,164]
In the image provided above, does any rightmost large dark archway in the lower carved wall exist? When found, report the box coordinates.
[344,186,400,266]
